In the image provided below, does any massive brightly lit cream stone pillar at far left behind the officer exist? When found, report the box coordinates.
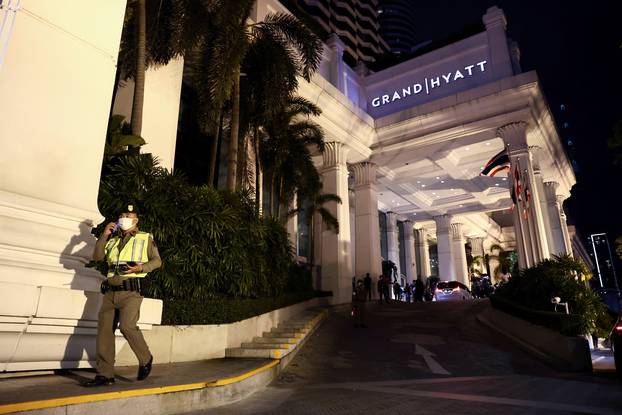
[0,0,162,372]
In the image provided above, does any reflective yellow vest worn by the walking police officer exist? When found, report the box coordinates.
[106,231,151,278]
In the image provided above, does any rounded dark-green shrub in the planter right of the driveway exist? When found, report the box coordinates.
[496,255,611,337]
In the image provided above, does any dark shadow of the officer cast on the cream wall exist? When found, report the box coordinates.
[59,220,105,369]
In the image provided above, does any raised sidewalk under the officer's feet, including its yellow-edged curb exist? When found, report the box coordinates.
[0,310,327,415]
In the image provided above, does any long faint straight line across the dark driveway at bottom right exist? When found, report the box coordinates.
[318,383,622,415]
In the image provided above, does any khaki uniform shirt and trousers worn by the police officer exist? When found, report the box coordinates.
[93,228,162,378]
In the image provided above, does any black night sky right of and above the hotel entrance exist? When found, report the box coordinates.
[412,0,622,245]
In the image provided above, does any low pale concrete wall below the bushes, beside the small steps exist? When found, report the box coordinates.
[116,298,327,366]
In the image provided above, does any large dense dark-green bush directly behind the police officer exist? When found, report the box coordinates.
[96,154,293,301]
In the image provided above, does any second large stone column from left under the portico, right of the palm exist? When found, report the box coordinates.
[352,161,382,280]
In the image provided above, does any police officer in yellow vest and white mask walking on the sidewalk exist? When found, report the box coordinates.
[83,205,162,387]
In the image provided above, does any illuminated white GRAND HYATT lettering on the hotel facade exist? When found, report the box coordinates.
[371,61,487,108]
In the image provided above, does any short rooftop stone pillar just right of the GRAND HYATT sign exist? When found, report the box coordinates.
[482,6,513,79]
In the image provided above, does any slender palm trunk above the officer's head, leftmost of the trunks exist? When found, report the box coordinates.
[131,0,147,136]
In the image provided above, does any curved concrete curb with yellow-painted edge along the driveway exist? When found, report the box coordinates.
[0,309,328,415]
